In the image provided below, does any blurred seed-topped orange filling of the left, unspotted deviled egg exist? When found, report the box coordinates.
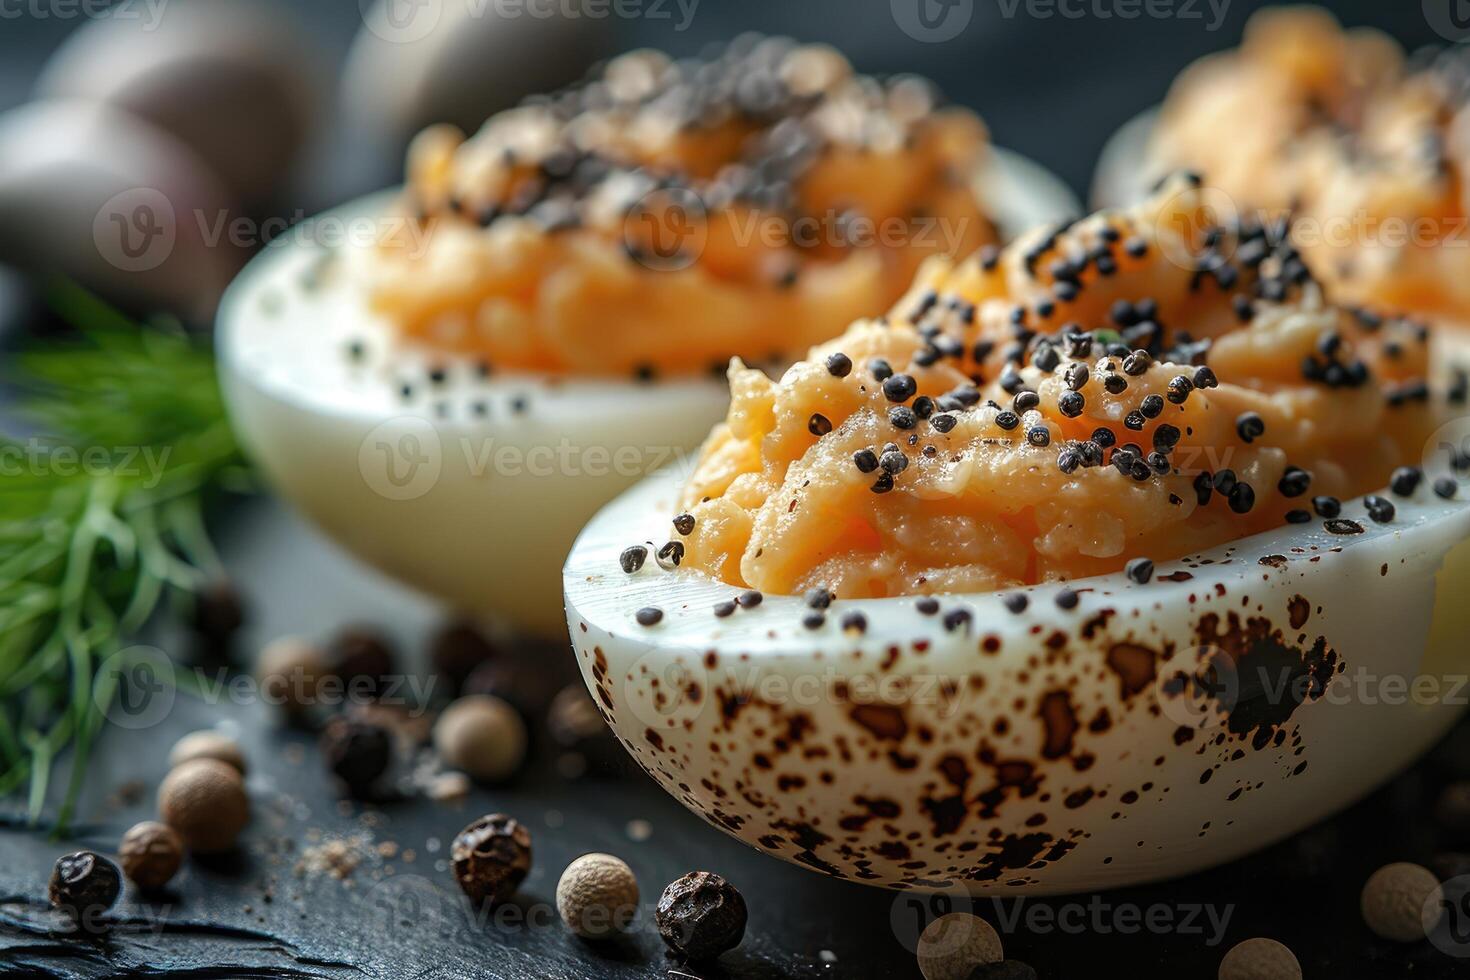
[365,37,995,376]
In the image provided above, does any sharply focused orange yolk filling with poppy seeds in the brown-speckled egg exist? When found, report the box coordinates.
[676,178,1446,598]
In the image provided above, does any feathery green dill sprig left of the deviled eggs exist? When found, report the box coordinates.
[0,287,243,830]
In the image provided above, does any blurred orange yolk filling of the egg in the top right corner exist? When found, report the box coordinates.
[1151,9,1470,320]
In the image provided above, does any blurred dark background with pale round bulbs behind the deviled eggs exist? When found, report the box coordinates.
[0,0,1458,333]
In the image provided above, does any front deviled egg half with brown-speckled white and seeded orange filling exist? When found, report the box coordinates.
[564,179,1470,893]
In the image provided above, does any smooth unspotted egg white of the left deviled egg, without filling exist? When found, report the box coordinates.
[218,164,1076,635]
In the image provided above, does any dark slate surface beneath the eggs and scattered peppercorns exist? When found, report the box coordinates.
[0,501,1470,980]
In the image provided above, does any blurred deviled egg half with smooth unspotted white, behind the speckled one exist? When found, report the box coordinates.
[219,38,1075,633]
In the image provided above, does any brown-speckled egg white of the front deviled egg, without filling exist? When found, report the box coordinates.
[563,464,1470,895]
